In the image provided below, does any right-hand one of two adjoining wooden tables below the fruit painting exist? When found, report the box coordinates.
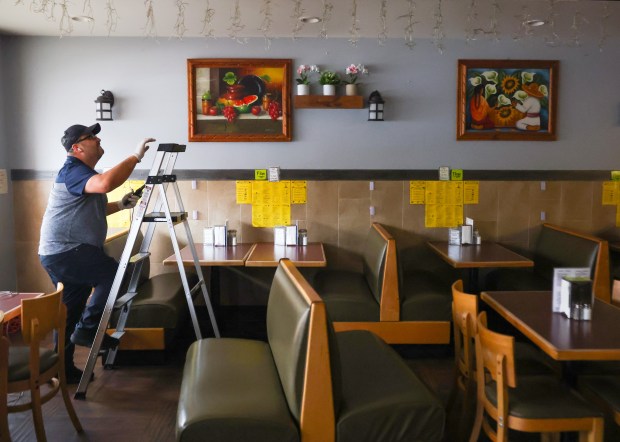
[245,242,327,267]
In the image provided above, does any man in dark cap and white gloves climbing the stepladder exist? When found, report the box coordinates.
[39,124,155,384]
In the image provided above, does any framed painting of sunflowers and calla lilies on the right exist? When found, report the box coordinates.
[456,60,559,141]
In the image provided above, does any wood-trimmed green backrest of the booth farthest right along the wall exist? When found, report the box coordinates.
[534,223,611,302]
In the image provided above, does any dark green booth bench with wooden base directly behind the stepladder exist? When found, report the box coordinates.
[104,230,197,350]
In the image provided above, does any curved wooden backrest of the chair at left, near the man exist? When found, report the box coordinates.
[21,283,66,345]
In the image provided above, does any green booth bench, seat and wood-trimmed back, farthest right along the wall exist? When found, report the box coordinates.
[485,224,611,302]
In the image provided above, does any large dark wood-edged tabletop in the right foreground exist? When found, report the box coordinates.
[481,291,620,361]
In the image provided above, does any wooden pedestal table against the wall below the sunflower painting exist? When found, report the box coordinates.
[427,241,534,293]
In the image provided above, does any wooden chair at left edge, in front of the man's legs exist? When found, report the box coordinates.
[0,283,83,442]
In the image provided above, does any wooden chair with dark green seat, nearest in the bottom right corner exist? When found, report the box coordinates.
[470,312,603,442]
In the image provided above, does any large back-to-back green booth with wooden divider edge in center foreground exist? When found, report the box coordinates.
[176,259,445,442]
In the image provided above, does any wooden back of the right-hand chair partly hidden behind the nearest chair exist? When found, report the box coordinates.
[452,279,478,380]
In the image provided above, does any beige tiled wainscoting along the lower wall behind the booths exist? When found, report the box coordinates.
[13,180,620,292]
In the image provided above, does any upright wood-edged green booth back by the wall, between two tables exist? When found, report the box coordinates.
[363,223,400,321]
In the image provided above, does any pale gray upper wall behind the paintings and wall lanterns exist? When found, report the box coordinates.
[0,31,620,288]
